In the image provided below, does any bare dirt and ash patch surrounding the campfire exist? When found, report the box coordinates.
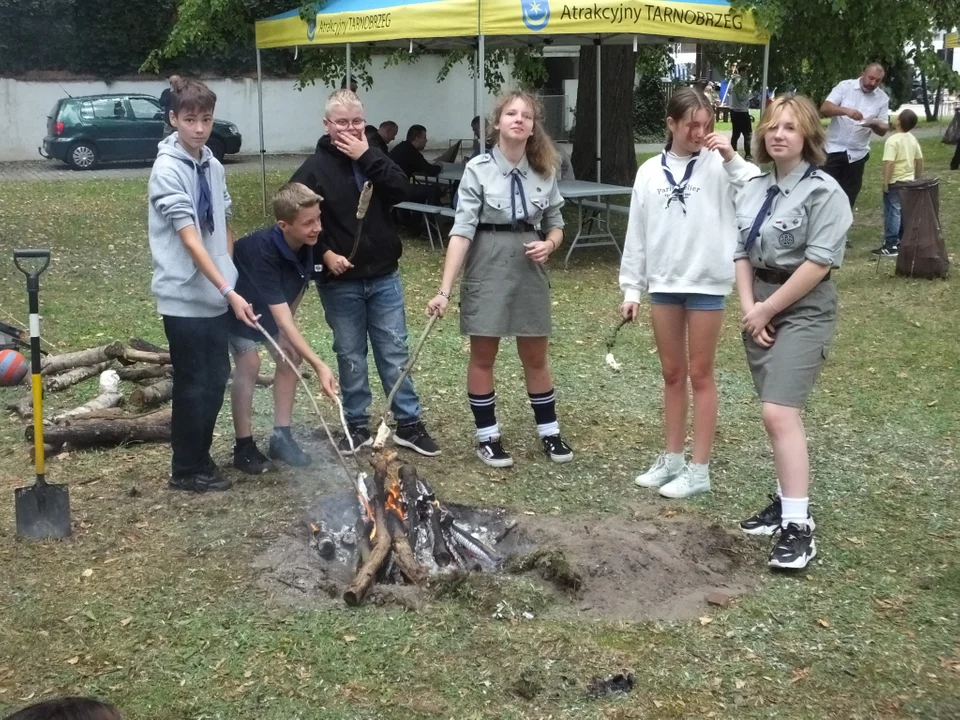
[254,494,758,622]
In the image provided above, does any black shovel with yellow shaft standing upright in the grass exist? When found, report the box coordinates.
[13,250,70,540]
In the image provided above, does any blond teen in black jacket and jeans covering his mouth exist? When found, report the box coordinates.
[291,90,440,456]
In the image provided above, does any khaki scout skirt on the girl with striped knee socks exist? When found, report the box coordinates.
[460,230,551,337]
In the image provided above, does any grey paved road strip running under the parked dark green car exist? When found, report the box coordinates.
[0,127,943,182]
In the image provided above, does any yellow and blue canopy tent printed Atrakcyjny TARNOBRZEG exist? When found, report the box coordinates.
[256,0,770,200]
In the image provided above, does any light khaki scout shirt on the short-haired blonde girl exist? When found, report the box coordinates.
[733,162,853,272]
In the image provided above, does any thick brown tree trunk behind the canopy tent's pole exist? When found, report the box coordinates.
[572,45,637,186]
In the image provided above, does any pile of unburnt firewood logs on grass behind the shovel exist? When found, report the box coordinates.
[7,338,273,454]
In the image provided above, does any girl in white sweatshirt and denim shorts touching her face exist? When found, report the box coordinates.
[620,88,760,498]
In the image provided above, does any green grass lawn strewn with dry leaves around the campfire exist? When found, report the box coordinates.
[0,140,960,720]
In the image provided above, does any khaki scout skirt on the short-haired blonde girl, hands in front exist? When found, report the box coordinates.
[743,279,837,408]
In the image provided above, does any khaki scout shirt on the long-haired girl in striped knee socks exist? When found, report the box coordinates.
[450,147,563,240]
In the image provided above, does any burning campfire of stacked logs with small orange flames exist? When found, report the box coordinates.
[308,450,502,606]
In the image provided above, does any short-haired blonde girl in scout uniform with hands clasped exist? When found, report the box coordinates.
[734,95,853,569]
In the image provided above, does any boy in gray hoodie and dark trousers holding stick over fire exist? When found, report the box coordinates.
[148,78,257,492]
